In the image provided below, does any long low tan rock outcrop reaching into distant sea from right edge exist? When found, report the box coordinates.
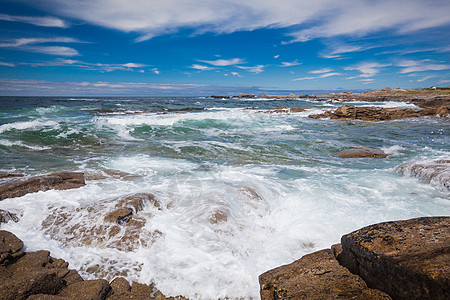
[309,104,447,121]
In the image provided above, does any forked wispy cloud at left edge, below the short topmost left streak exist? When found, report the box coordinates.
[0,37,84,56]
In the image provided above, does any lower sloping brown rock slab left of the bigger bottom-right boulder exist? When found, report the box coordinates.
[259,249,391,300]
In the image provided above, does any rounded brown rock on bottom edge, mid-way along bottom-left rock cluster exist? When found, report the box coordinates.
[58,279,111,300]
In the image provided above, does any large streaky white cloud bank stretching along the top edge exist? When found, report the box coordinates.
[30,0,450,41]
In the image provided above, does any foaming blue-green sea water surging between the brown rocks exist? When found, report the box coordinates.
[0,97,450,299]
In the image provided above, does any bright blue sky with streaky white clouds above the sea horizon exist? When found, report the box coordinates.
[0,0,450,96]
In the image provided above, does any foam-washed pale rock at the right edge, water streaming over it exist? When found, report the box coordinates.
[397,160,450,191]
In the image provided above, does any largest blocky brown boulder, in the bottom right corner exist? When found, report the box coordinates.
[337,217,450,299]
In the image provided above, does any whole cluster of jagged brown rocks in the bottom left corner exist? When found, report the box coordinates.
[0,230,187,300]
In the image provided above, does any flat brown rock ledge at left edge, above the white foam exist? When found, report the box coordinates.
[0,172,85,200]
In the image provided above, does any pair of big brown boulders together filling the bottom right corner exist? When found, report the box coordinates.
[259,217,450,300]
